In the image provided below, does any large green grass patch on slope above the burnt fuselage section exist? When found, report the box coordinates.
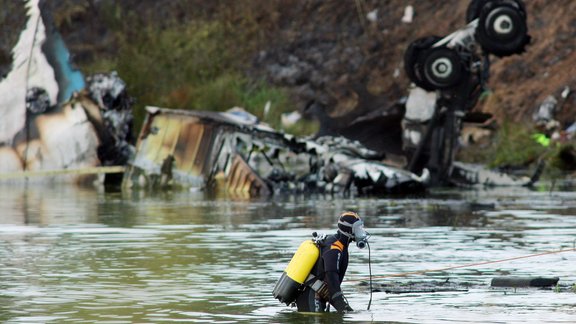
[76,3,317,135]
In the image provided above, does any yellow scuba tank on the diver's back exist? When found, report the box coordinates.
[272,240,320,305]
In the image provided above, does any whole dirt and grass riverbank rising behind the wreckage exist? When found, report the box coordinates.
[0,0,576,177]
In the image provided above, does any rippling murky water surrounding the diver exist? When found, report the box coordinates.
[0,186,576,323]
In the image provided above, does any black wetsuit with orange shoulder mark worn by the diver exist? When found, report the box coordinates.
[296,233,351,312]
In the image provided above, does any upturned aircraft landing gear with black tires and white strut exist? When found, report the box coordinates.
[402,0,543,186]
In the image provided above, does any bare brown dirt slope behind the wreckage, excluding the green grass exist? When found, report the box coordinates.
[0,0,576,131]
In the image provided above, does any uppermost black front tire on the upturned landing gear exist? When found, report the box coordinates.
[475,0,530,57]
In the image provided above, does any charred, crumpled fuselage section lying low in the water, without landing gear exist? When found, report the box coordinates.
[123,107,429,196]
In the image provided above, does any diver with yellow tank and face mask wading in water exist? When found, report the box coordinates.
[273,211,369,313]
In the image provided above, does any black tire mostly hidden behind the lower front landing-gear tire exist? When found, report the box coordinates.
[404,36,442,91]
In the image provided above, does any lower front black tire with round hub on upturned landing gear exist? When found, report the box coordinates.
[419,47,465,90]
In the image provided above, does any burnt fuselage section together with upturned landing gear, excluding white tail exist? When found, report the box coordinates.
[124,0,542,195]
